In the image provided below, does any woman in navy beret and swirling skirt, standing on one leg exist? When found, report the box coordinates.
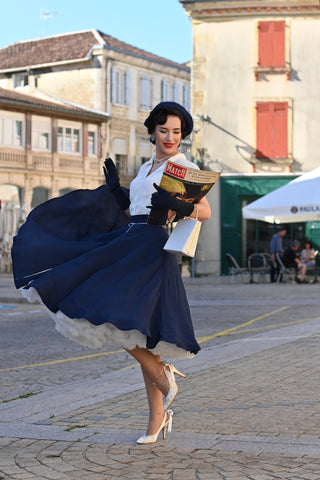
[12,102,211,444]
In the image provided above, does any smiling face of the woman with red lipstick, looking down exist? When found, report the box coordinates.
[153,115,181,158]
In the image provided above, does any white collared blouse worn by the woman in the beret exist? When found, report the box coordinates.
[130,153,199,215]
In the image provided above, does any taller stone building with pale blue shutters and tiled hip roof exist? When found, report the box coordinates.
[0,29,190,186]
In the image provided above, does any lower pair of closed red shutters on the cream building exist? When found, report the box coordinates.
[256,102,288,159]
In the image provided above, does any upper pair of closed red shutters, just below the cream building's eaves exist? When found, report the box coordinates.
[258,20,286,67]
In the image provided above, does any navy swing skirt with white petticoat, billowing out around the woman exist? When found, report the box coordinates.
[12,186,200,358]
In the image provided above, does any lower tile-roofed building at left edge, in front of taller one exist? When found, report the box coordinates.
[0,87,109,260]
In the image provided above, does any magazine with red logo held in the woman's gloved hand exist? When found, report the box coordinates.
[147,160,220,225]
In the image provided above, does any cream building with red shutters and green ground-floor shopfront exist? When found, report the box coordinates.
[180,0,320,273]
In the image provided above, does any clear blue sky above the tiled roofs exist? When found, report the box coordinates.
[0,0,192,63]
